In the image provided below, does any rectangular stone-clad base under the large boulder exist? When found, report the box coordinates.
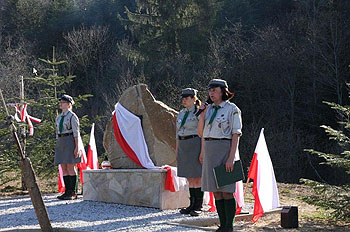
[83,169,189,209]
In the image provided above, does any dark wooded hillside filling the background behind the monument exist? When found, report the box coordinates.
[0,0,350,188]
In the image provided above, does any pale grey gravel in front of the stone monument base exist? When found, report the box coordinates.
[0,194,216,231]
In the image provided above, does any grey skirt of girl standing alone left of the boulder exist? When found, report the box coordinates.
[55,135,80,164]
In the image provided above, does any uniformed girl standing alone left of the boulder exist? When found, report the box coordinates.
[55,94,80,200]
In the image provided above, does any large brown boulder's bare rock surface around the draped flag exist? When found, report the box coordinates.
[103,84,178,168]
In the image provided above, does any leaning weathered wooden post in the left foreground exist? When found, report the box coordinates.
[0,89,53,232]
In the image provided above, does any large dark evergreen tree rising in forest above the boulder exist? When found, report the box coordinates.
[119,0,220,82]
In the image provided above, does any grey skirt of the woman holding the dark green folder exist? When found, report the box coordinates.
[202,140,236,193]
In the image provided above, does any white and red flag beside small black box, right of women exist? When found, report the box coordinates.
[248,128,279,223]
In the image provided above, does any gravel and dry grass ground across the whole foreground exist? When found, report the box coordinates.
[0,183,350,232]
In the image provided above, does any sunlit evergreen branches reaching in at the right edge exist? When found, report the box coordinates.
[304,84,350,221]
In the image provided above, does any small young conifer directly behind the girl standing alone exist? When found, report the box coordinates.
[27,47,92,178]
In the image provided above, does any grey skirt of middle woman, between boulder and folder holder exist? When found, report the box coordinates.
[177,137,202,178]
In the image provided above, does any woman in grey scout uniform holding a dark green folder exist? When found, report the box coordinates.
[198,79,242,231]
